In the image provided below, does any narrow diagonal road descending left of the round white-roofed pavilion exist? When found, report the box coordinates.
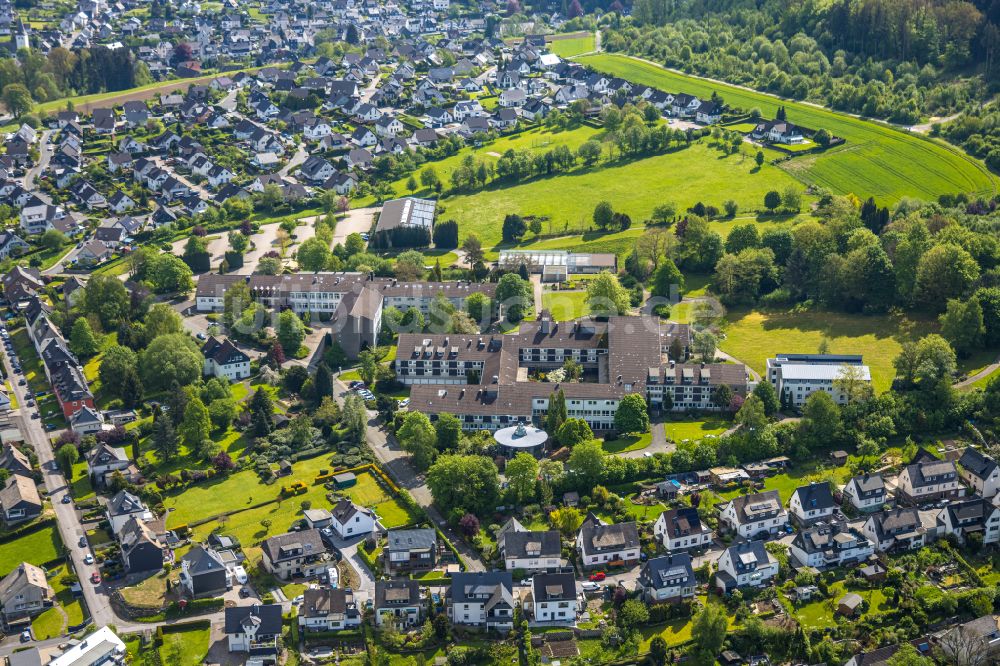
[334,377,486,571]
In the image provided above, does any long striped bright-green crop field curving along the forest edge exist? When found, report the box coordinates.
[579,54,997,204]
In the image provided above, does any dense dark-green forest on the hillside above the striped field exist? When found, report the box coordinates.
[603,0,1000,131]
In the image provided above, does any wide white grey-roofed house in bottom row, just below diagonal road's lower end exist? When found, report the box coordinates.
[448,571,514,631]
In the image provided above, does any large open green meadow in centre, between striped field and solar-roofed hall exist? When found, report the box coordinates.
[440,141,797,253]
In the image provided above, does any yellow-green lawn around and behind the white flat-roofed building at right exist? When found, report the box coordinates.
[719,310,988,393]
